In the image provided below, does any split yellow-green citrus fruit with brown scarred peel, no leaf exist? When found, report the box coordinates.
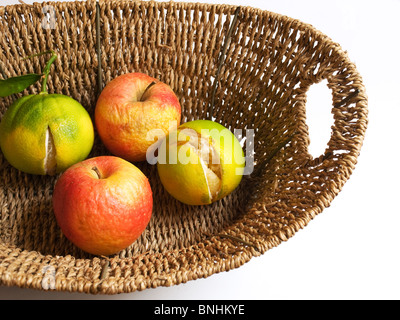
[157,120,245,205]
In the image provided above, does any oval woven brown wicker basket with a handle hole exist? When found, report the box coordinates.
[0,0,367,294]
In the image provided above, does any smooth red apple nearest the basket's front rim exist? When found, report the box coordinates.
[53,156,153,255]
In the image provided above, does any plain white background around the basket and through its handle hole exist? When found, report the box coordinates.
[0,0,400,300]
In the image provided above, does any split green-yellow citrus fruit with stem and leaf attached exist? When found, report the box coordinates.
[0,93,94,175]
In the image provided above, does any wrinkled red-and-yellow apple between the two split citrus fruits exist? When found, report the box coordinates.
[95,73,181,162]
